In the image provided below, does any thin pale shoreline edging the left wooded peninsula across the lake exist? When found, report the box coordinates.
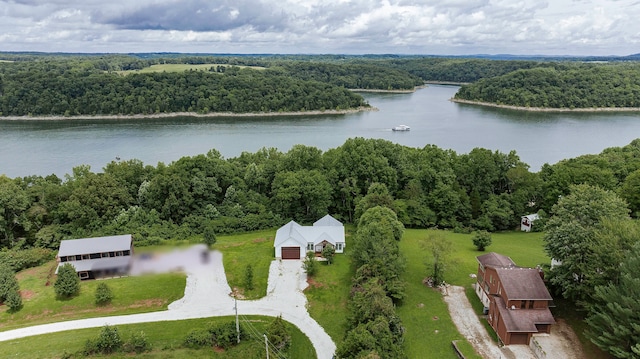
[0,106,378,121]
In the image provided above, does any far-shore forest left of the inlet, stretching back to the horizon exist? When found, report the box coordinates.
[0,54,580,116]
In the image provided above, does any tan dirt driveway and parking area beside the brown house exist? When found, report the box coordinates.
[443,286,584,359]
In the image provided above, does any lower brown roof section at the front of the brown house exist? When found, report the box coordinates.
[496,297,556,333]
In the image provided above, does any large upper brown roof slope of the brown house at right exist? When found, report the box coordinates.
[496,268,553,300]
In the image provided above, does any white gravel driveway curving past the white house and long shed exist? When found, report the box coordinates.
[0,247,336,359]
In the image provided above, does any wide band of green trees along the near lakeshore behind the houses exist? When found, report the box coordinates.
[0,138,640,249]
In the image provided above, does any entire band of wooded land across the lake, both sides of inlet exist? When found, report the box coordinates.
[0,53,640,118]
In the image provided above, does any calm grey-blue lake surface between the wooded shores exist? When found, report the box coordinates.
[0,86,640,177]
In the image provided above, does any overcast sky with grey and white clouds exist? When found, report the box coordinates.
[0,0,640,55]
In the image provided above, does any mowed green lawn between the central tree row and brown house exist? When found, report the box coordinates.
[397,229,549,359]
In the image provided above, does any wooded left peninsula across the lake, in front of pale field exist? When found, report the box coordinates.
[0,62,368,116]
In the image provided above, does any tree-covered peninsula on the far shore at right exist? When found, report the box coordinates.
[455,63,640,109]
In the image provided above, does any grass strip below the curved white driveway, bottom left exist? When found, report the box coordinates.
[0,316,316,359]
